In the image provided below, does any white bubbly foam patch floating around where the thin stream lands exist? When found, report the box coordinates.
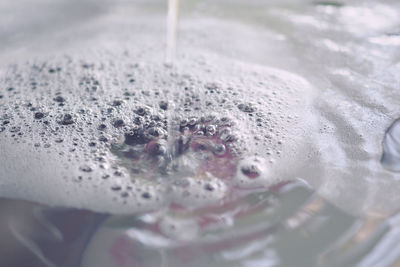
[0,45,309,213]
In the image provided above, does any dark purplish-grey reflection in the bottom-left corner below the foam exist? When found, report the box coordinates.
[0,198,105,267]
